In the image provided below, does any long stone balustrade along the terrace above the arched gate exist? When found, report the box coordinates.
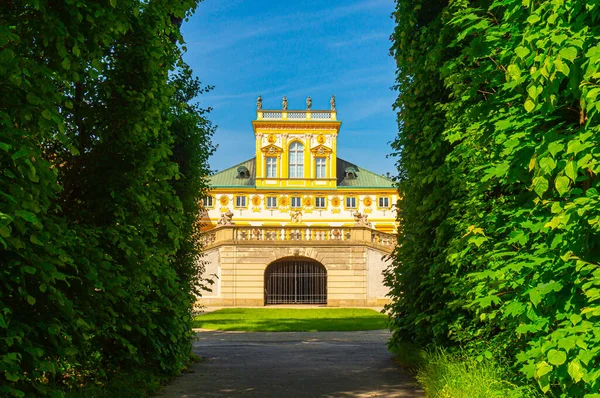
[201,225,396,253]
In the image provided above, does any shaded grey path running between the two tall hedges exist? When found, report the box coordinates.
[159,330,424,398]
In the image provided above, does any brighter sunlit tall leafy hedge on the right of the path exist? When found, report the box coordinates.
[386,0,600,397]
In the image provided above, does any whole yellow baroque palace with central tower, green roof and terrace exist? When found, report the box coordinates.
[199,96,397,306]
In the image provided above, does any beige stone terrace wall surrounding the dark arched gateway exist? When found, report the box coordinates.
[199,244,387,307]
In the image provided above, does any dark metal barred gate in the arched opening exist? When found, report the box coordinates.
[265,259,327,305]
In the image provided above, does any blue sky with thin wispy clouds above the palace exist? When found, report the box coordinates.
[183,0,397,175]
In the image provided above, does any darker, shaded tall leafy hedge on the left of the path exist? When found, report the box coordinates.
[0,0,213,396]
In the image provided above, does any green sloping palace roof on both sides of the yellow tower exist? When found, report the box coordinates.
[210,158,394,188]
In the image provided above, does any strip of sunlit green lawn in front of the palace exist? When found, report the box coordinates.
[194,308,387,332]
